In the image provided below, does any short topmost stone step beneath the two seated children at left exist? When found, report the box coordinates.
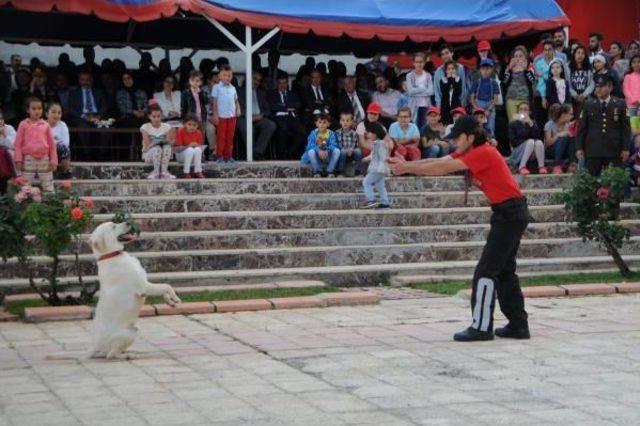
[73,161,311,179]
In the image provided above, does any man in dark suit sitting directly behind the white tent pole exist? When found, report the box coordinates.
[238,70,276,160]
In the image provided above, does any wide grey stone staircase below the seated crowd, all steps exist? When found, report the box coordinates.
[0,162,640,292]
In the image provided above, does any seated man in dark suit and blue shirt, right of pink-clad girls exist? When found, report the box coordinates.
[66,70,109,160]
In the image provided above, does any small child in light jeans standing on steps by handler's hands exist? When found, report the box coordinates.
[362,122,393,209]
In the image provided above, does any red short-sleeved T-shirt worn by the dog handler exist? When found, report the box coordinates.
[456,143,522,204]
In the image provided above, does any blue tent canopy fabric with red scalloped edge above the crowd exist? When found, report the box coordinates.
[0,0,569,43]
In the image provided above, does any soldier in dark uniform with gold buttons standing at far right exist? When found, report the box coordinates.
[576,74,631,176]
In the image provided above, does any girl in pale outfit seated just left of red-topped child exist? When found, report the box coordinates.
[140,105,175,179]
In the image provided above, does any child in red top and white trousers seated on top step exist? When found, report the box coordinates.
[173,114,204,179]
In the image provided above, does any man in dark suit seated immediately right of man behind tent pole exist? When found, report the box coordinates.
[268,75,306,160]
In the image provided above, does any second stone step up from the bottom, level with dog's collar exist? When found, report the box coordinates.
[6,237,640,278]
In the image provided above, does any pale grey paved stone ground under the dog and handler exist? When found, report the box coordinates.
[0,295,640,426]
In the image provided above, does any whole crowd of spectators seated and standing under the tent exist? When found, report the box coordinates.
[0,28,640,186]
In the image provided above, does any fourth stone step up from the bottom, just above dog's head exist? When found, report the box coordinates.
[95,203,638,232]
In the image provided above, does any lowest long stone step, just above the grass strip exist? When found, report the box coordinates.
[0,255,640,294]
